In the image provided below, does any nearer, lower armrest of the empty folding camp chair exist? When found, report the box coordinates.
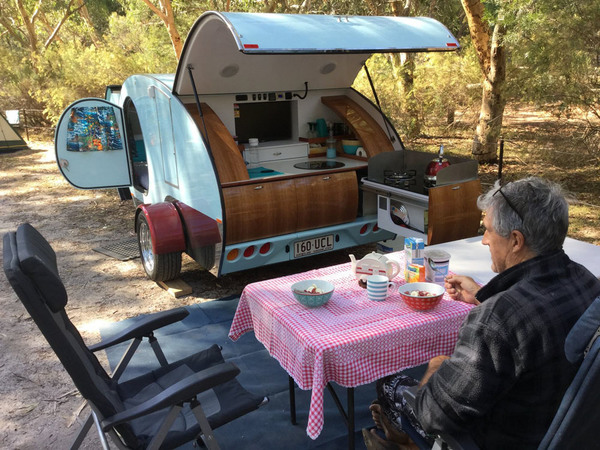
[102,363,240,431]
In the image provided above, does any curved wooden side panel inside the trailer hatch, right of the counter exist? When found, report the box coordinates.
[321,95,394,158]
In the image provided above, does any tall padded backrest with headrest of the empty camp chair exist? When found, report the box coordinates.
[3,223,135,442]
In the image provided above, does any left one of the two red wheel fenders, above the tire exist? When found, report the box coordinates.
[136,202,185,255]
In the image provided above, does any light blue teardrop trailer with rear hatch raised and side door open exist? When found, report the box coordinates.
[55,12,478,281]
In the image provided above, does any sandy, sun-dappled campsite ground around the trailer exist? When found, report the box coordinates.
[0,104,600,449]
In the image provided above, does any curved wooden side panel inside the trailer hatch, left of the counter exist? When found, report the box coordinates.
[185,103,250,184]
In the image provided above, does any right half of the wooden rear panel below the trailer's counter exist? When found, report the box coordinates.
[294,171,358,231]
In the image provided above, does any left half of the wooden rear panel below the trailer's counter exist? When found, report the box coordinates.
[223,180,297,244]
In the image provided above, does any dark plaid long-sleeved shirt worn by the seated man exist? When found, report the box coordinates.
[416,250,600,449]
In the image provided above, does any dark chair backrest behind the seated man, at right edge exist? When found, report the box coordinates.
[539,297,600,449]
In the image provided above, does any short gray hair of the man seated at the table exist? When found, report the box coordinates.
[477,177,569,255]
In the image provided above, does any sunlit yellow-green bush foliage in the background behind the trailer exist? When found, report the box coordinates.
[0,0,600,146]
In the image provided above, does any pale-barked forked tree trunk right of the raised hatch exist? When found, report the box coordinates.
[461,0,506,162]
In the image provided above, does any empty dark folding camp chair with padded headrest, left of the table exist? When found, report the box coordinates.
[4,224,267,449]
